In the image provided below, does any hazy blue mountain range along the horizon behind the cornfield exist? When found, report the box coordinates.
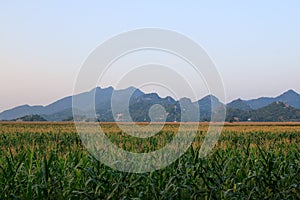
[0,87,300,122]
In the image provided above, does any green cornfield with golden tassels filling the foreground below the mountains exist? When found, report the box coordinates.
[0,122,300,199]
